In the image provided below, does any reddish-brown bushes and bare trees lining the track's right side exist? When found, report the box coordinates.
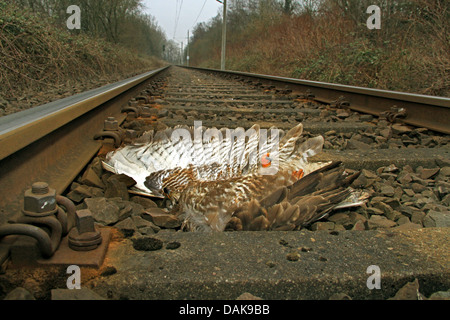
[190,0,450,95]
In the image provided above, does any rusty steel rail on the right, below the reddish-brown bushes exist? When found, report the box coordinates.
[182,66,450,134]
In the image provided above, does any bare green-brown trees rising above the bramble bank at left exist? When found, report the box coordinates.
[12,0,179,60]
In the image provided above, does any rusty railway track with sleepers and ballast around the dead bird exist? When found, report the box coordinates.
[0,67,450,299]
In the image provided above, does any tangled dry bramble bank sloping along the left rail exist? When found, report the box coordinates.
[0,1,161,104]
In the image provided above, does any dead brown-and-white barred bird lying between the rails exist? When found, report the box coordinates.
[104,124,368,231]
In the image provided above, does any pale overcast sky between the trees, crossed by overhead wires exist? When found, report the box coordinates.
[143,0,223,43]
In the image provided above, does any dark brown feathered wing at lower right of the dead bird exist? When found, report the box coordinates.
[221,162,363,231]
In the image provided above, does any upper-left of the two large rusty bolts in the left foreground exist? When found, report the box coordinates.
[23,182,58,217]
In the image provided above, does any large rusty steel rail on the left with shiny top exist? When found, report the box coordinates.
[0,67,169,225]
